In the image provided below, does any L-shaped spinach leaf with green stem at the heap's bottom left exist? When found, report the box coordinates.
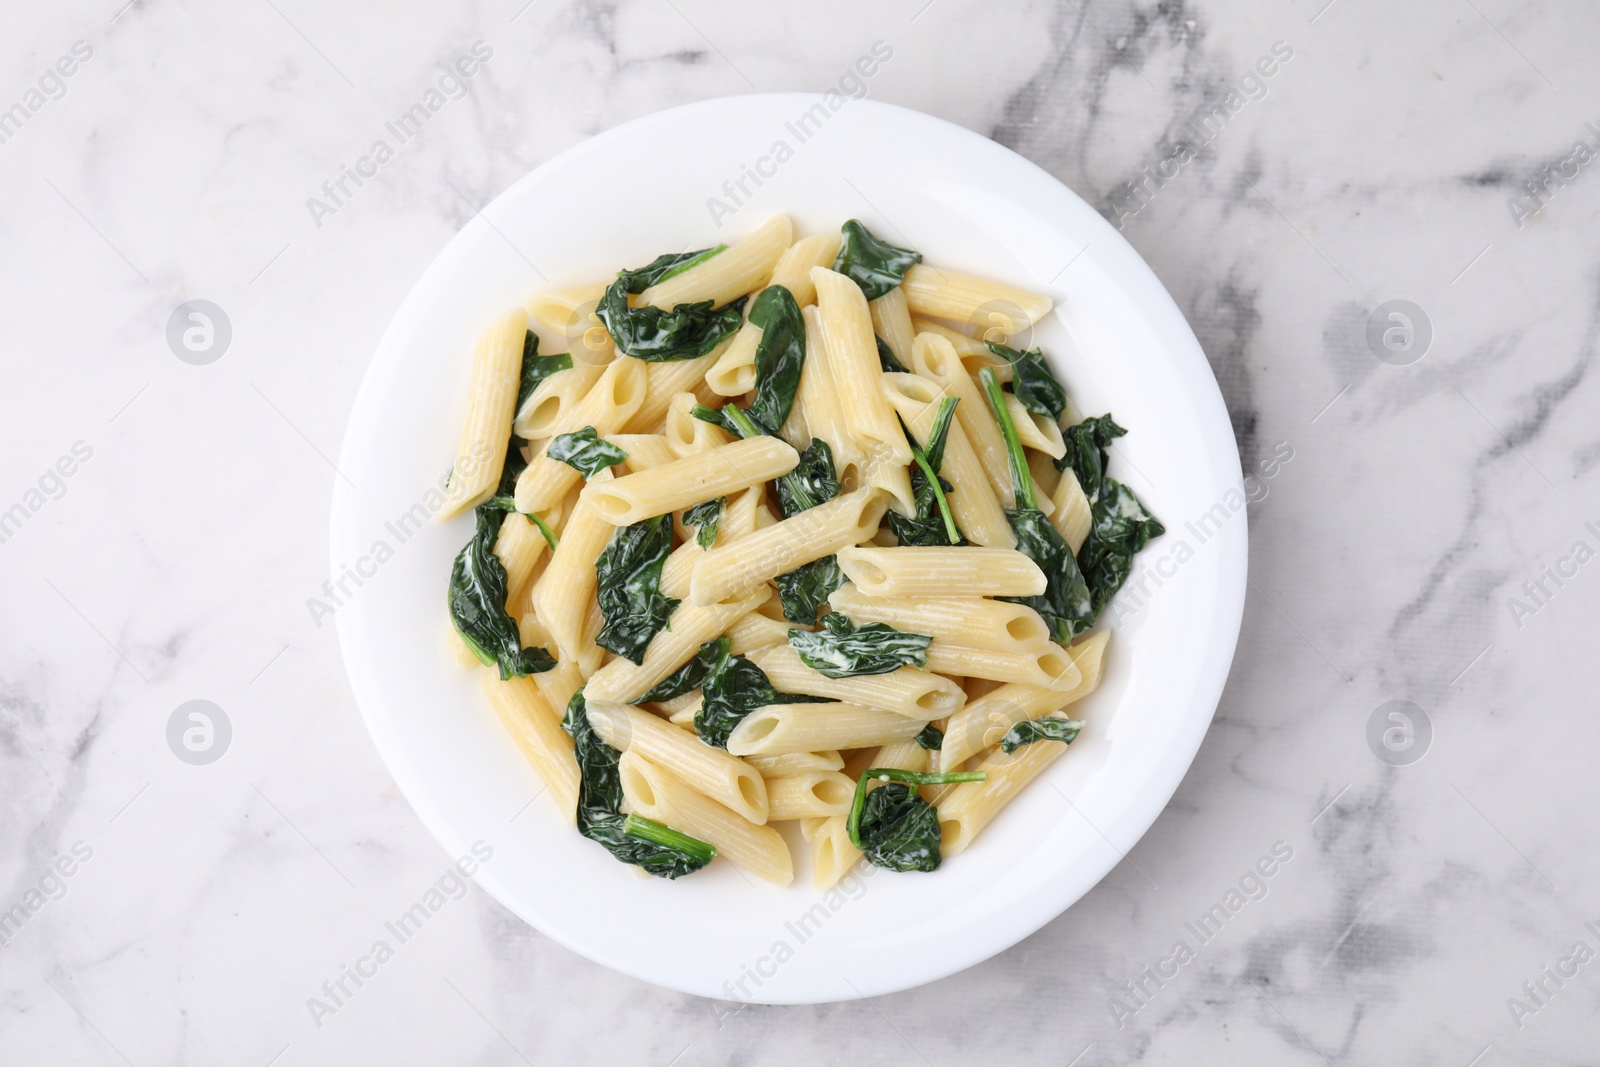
[562,689,717,878]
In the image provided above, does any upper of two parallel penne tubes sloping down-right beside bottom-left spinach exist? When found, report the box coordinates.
[586,693,768,825]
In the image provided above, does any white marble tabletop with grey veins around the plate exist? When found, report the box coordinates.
[0,0,1600,1067]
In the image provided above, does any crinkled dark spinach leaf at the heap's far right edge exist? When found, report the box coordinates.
[1056,414,1166,614]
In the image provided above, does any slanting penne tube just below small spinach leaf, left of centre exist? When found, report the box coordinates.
[584,437,800,526]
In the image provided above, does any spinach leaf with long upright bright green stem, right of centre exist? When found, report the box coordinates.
[978,366,1094,643]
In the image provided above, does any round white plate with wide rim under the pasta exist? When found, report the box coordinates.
[333,94,1245,1003]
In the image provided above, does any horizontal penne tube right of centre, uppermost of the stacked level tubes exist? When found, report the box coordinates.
[838,545,1045,597]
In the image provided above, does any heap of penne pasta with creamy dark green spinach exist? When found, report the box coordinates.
[438,216,1163,888]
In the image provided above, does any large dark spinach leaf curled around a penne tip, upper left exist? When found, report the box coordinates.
[595,248,744,363]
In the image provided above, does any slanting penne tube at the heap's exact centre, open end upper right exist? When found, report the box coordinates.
[690,488,889,605]
